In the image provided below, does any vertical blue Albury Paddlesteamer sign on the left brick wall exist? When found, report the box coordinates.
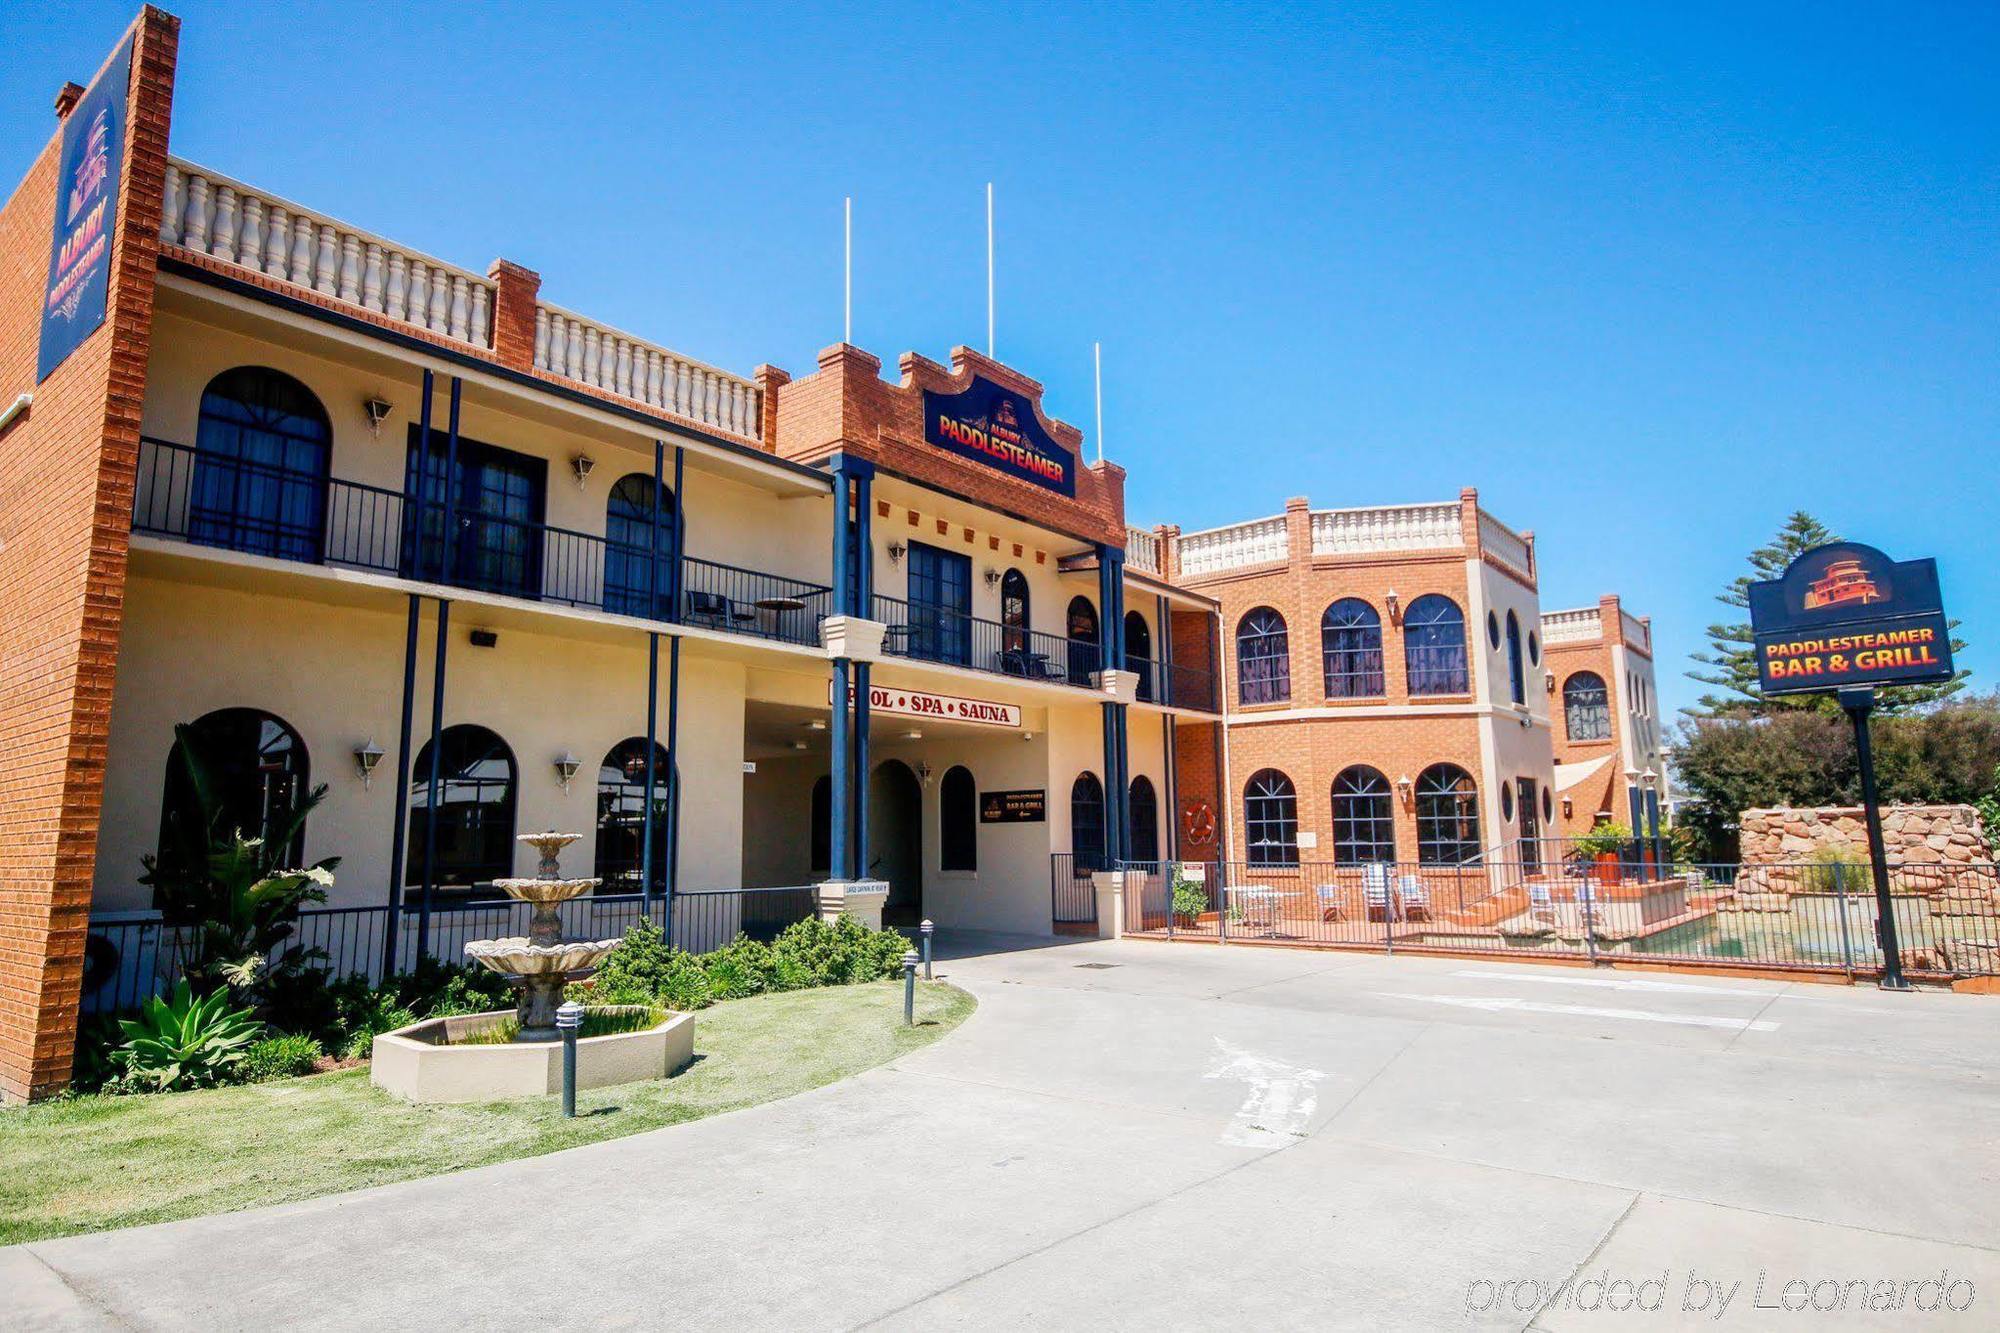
[34,36,132,384]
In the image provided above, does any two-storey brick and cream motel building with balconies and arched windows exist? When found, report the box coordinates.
[0,8,1658,1097]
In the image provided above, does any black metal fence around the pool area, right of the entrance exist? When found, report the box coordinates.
[1104,857,2000,981]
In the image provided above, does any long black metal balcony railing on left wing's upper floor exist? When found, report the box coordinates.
[132,436,832,646]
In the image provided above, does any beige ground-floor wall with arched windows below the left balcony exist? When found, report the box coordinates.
[96,576,744,911]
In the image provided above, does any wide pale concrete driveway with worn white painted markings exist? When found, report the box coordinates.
[0,939,2000,1331]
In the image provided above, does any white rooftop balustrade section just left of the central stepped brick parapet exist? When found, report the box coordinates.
[534,304,760,438]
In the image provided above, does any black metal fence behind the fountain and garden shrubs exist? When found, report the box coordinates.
[82,885,818,1013]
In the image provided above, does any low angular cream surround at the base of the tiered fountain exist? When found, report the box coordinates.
[368,1009,694,1103]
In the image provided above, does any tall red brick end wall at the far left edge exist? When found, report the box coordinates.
[0,8,180,1099]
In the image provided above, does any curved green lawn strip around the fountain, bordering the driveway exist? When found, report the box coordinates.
[0,981,974,1245]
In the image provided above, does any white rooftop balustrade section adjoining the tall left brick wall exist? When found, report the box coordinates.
[160,158,494,346]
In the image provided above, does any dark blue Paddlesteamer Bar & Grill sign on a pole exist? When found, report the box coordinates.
[1750,542,1952,991]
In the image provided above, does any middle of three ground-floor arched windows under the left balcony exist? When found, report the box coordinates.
[404,723,514,889]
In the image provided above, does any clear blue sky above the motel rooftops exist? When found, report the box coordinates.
[0,0,2000,707]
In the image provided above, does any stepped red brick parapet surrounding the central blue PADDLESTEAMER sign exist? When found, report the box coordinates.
[762,344,1126,550]
